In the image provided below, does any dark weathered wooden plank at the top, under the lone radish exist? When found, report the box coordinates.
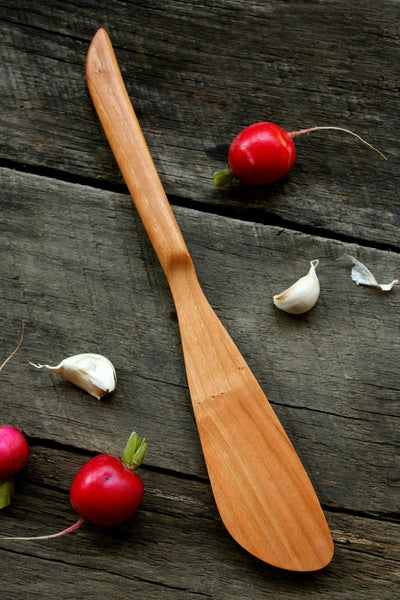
[0,0,399,248]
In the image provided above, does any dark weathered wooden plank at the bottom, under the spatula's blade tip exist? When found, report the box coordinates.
[0,446,400,600]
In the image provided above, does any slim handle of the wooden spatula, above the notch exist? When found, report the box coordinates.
[86,29,191,280]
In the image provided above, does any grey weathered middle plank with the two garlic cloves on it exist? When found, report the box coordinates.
[0,163,400,518]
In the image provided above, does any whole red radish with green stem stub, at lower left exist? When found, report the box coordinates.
[0,432,148,540]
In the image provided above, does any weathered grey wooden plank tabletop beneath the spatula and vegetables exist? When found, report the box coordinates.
[0,0,400,600]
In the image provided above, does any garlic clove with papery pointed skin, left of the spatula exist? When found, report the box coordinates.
[30,353,117,400]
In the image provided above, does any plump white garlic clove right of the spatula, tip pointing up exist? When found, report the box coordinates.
[273,260,320,315]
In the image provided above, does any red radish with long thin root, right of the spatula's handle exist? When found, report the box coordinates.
[214,121,385,186]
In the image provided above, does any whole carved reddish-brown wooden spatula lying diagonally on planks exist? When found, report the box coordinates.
[86,29,333,571]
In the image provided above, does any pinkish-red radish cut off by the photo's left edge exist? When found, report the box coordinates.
[0,425,29,508]
